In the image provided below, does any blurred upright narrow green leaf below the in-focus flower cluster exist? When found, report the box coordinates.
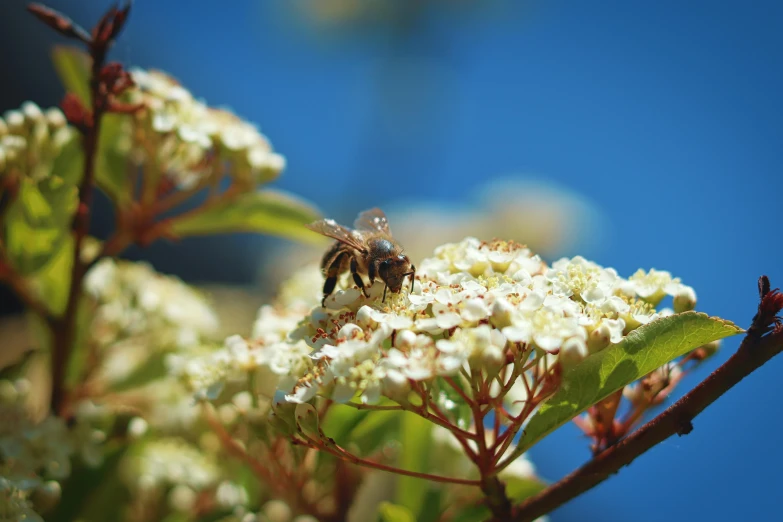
[395,413,433,513]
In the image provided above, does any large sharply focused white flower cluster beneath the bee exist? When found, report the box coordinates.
[187,238,695,403]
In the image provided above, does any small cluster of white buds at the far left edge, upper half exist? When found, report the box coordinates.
[0,101,77,181]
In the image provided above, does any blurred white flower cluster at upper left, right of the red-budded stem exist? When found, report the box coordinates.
[130,69,285,189]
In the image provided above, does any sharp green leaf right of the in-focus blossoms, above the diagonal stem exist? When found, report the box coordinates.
[514,312,743,455]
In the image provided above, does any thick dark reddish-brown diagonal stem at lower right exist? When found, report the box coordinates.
[510,329,783,522]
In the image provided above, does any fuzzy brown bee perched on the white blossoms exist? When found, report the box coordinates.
[305,208,416,307]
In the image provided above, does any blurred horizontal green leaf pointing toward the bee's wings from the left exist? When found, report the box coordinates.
[171,190,322,242]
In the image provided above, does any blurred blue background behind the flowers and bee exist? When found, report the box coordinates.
[0,0,783,522]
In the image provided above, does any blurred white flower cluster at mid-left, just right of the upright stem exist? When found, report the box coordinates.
[84,258,218,382]
